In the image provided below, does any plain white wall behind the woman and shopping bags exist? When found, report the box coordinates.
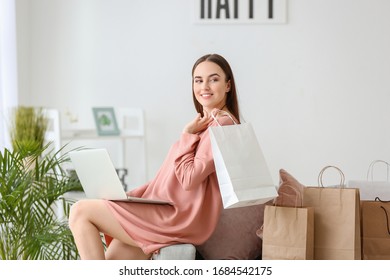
[16,0,390,188]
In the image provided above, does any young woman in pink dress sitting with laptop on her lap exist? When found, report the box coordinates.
[69,54,240,259]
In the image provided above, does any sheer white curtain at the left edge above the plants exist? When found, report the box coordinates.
[0,0,18,151]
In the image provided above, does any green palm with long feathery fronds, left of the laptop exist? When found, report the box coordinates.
[0,145,81,260]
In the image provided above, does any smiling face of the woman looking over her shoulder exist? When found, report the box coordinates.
[192,61,230,112]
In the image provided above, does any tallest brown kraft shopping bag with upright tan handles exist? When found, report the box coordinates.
[303,166,361,260]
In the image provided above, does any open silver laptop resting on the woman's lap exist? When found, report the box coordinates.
[69,149,172,204]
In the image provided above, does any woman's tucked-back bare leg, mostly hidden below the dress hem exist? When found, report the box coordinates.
[106,239,151,260]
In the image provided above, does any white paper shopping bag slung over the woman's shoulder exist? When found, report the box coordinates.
[209,117,278,209]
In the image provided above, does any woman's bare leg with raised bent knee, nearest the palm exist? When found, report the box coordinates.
[69,199,145,260]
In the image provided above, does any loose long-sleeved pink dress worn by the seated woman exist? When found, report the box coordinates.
[106,116,233,254]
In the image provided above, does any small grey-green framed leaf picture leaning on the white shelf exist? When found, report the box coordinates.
[92,107,120,136]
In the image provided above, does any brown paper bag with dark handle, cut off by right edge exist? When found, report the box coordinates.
[361,198,390,260]
